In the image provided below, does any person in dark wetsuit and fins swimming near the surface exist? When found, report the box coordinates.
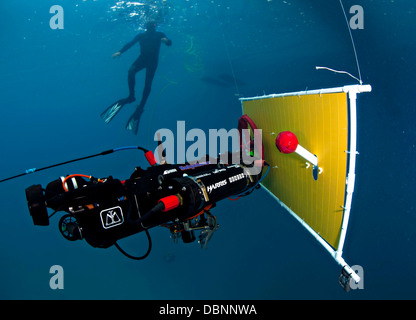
[101,21,172,134]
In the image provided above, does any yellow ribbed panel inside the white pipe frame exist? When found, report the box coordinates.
[243,92,348,249]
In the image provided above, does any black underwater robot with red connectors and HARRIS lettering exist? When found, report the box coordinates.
[26,148,263,260]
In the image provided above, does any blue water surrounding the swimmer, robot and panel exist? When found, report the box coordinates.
[0,0,416,299]
